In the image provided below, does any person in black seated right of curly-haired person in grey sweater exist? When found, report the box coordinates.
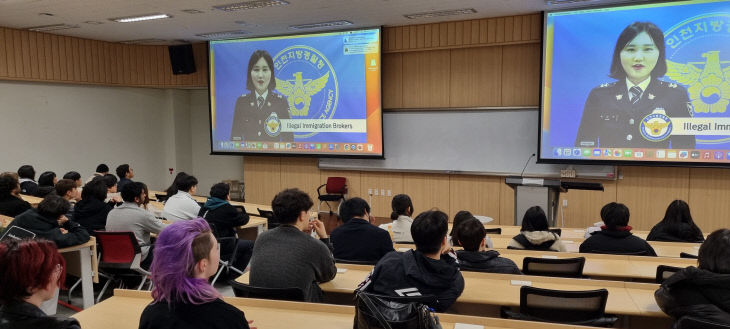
[330,197,395,262]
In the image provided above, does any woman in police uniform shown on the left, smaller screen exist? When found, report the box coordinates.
[231,50,294,142]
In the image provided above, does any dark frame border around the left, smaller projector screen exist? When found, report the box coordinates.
[206,26,385,159]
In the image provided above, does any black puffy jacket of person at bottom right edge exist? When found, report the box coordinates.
[654,266,730,325]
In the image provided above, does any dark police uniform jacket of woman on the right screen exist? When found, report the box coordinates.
[575,78,695,149]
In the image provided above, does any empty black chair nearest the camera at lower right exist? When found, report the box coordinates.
[502,286,618,327]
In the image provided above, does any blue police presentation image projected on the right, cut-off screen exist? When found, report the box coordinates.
[539,0,730,166]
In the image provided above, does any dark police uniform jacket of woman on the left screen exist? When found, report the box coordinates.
[231,90,294,142]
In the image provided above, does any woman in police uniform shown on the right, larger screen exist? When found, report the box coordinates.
[575,22,695,149]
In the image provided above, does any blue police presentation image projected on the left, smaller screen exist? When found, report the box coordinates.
[208,28,383,157]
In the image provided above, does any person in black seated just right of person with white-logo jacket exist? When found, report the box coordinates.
[456,218,522,274]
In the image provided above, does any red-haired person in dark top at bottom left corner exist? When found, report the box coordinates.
[0,239,80,329]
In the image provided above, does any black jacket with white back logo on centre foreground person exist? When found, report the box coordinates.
[365,250,464,312]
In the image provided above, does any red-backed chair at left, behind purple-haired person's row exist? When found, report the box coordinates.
[94,231,152,303]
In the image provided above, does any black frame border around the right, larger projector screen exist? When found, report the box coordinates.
[535,0,730,168]
